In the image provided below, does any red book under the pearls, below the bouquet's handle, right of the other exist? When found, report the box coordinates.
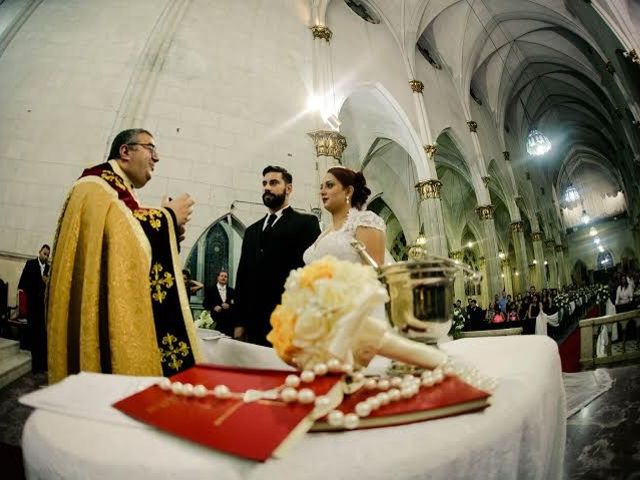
[311,377,491,432]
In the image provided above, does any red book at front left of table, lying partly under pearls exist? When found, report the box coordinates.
[113,365,342,461]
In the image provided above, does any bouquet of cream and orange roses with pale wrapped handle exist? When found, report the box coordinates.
[267,256,447,370]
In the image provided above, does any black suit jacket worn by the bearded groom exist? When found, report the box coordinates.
[236,207,320,346]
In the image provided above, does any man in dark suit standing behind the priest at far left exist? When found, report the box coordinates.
[18,245,51,373]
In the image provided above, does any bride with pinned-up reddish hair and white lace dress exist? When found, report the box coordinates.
[303,167,385,265]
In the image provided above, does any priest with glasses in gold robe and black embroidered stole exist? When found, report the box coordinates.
[47,129,200,383]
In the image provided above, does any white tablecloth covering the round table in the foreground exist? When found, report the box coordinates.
[22,335,566,480]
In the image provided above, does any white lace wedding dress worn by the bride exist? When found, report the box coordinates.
[303,208,386,265]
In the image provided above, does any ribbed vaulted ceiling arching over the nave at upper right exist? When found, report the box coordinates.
[375,0,640,230]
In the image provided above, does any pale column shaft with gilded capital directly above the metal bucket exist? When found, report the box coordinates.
[415,178,448,257]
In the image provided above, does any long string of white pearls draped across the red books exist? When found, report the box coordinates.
[157,358,496,430]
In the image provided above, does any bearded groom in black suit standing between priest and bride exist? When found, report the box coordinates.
[234,166,320,346]
